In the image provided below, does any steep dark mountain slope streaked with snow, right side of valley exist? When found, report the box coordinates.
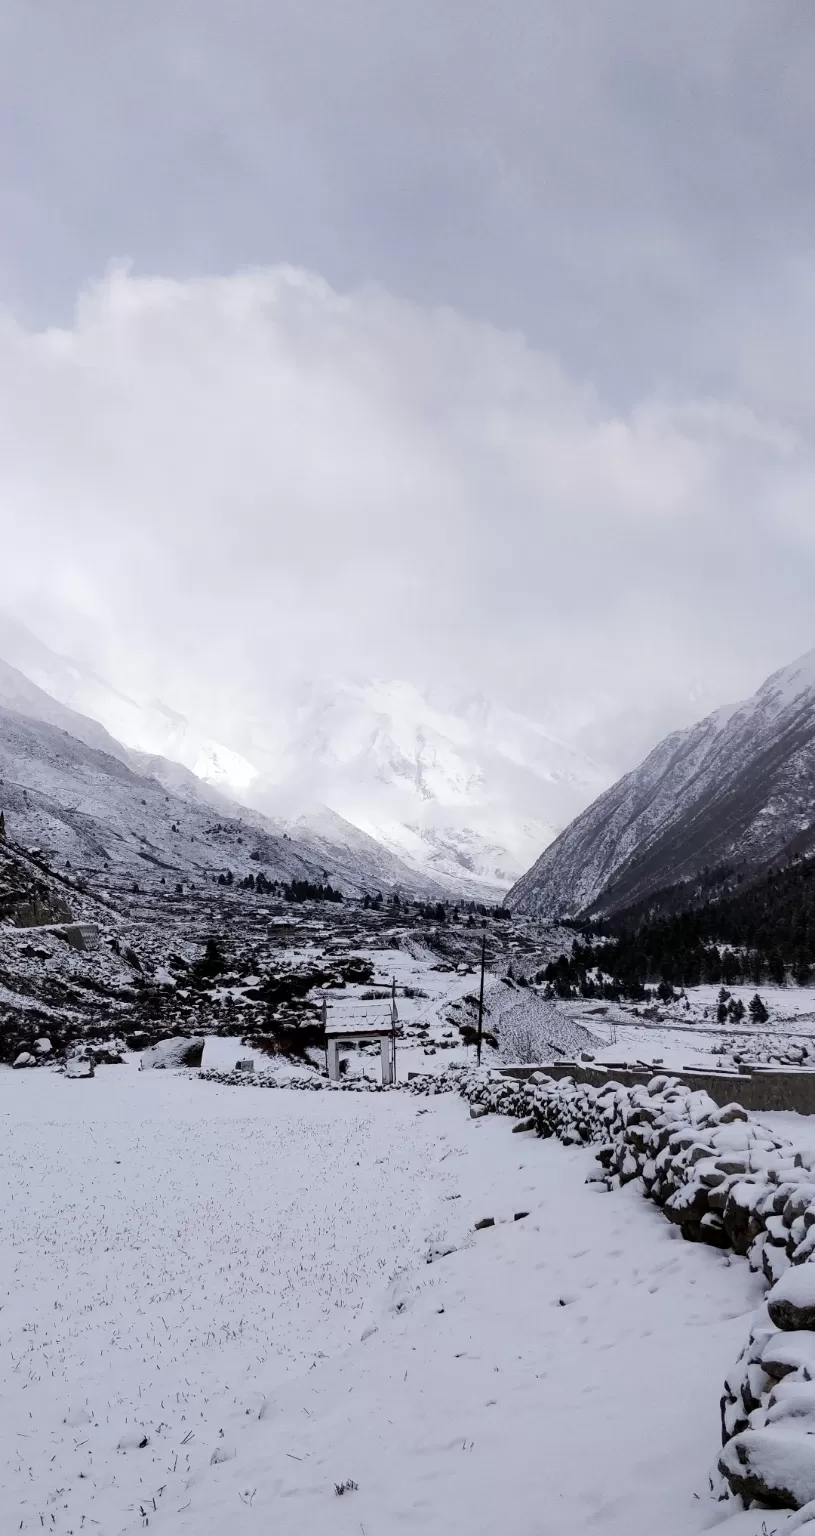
[506,651,815,917]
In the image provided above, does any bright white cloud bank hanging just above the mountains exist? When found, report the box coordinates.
[0,267,815,760]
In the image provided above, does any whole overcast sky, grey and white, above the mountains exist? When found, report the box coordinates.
[0,0,815,763]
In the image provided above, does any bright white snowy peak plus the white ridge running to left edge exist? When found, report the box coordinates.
[0,617,611,900]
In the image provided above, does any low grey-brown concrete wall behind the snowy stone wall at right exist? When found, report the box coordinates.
[502,1061,815,1115]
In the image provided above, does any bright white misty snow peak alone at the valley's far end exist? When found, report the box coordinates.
[233,682,609,892]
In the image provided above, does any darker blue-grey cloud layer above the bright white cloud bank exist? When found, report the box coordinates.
[0,0,815,412]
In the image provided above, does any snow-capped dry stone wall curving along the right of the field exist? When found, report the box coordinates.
[420,1072,815,1521]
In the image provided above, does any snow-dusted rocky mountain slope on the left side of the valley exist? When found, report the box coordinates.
[0,664,440,897]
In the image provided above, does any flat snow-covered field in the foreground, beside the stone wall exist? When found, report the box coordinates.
[0,1068,772,1536]
